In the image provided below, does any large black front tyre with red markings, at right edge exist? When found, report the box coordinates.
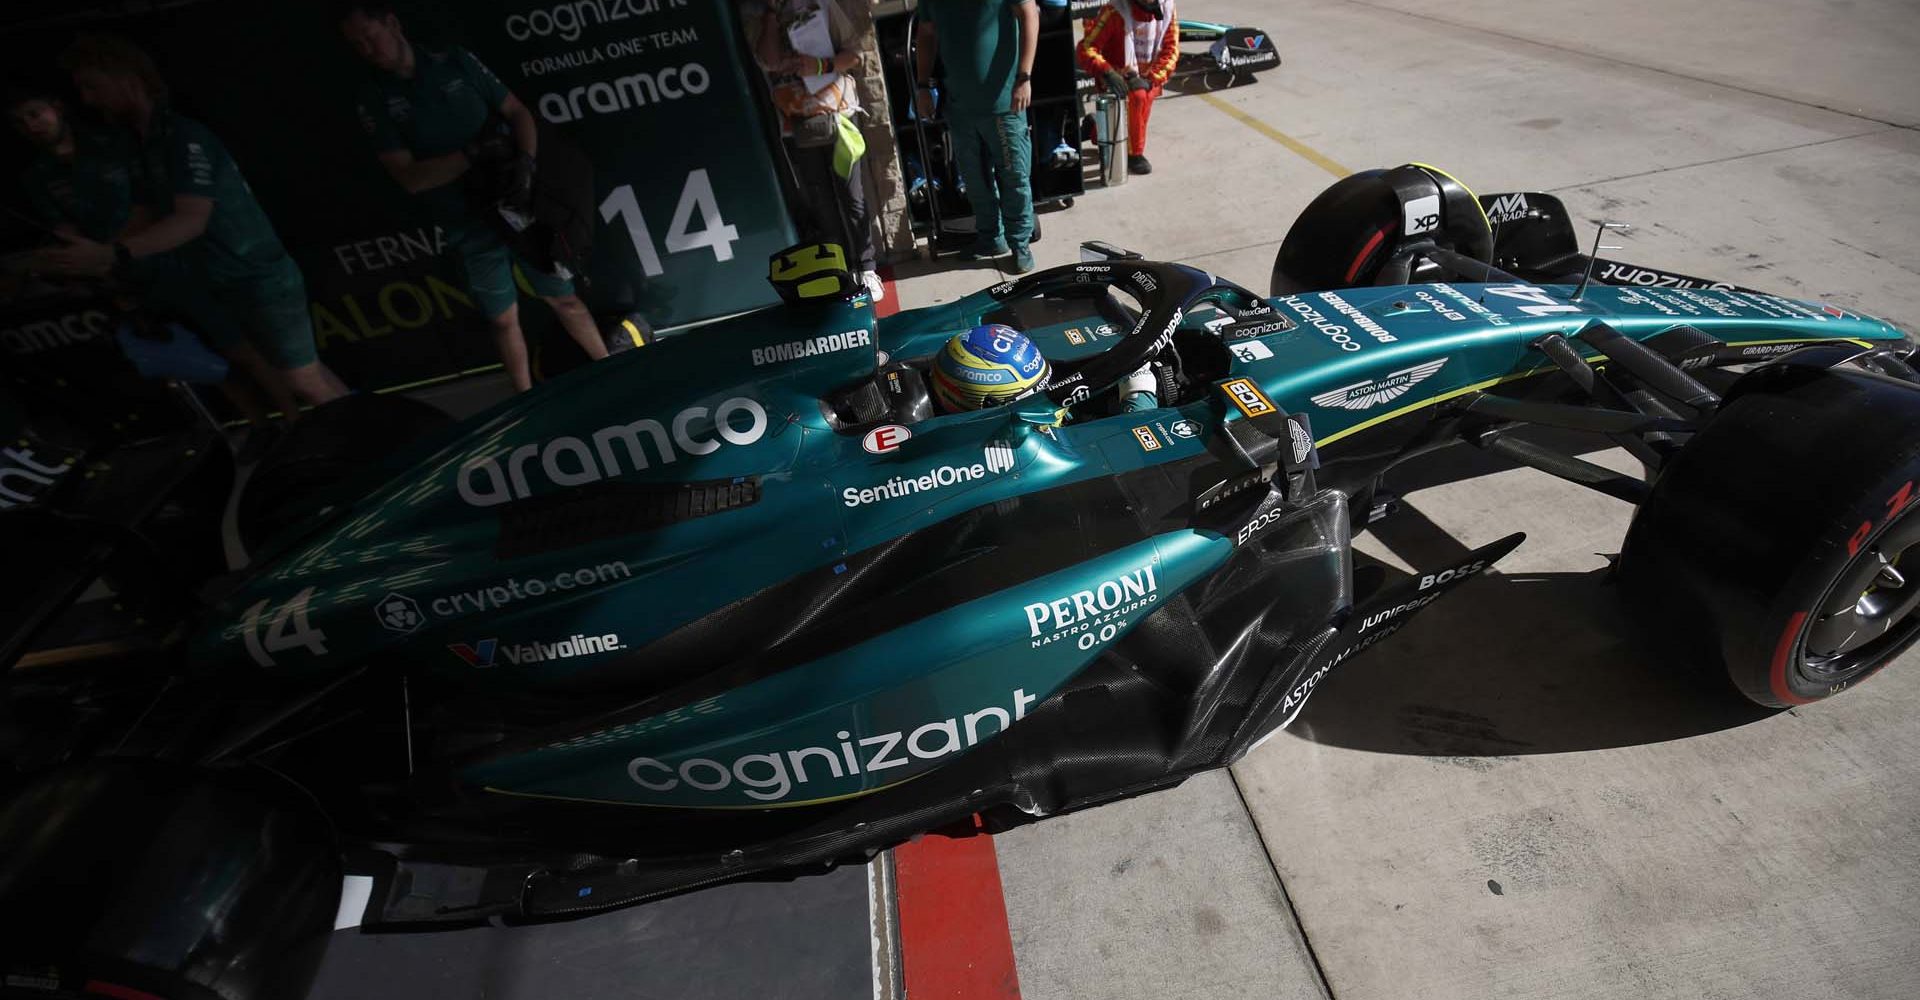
[1620,367,1920,708]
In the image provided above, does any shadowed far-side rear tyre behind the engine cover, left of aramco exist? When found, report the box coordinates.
[236,393,453,553]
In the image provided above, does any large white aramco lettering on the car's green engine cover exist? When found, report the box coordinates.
[453,395,766,507]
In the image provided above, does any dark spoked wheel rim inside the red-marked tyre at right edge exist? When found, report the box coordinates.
[1799,509,1920,685]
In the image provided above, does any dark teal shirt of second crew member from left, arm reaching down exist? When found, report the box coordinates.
[132,107,290,286]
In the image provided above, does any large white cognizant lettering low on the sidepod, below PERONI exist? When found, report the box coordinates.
[626,689,1039,802]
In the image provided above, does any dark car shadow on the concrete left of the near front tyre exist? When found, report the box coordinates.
[1288,441,1776,756]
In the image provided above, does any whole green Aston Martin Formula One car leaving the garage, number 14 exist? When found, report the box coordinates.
[0,165,1920,996]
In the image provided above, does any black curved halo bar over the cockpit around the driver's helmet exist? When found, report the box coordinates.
[987,261,1213,407]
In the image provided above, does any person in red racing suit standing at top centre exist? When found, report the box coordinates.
[1075,0,1181,173]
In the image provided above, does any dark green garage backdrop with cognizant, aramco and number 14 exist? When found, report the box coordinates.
[0,0,793,390]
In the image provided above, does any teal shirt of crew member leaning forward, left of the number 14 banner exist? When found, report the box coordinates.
[359,46,507,228]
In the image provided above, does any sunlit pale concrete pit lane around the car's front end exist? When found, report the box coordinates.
[899,0,1920,1000]
